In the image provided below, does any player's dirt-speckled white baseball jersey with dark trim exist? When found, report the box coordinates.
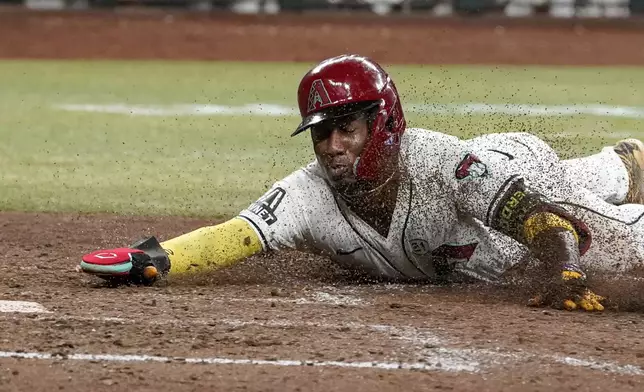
[239,128,644,281]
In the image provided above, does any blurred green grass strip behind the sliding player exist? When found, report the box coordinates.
[0,61,644,217]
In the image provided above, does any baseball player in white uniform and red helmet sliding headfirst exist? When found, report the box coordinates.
[80,55,644,311]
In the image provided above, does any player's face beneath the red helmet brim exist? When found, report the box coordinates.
[311,115,369,190]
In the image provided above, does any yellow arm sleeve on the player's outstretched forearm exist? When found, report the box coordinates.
[161,217,262,275]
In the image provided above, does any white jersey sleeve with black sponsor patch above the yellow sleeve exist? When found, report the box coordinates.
[239,182,306,250]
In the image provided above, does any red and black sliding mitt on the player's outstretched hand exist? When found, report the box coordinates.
[80,237,170,285]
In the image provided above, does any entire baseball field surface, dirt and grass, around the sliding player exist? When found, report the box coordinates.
[0,9,644,392]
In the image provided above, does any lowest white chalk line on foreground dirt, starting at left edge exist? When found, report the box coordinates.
[0,351,449,371]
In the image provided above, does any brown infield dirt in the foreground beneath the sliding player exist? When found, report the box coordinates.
[0,213,644,391]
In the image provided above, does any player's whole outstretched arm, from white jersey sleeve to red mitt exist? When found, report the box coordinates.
[80,176,316,284]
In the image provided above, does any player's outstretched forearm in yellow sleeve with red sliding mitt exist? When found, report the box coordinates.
[80,217,263,284]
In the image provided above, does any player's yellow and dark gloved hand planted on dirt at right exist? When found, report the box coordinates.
[528,264,605,312]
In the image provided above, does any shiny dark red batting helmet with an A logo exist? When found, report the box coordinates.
[292,55,406,179]
